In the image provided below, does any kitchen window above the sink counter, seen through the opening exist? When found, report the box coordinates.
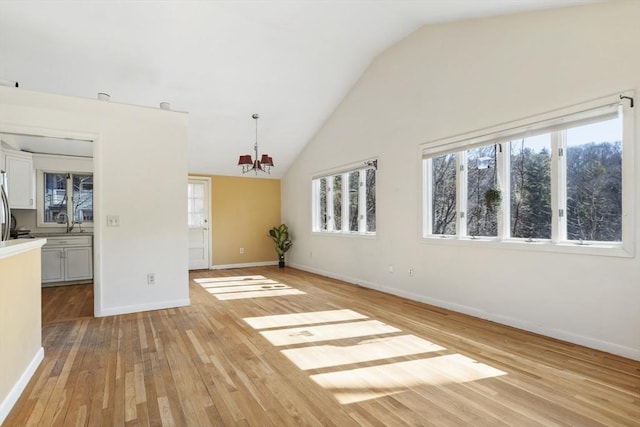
[42,172,93,224]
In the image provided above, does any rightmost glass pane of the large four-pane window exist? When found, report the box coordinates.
[567,119,622,242]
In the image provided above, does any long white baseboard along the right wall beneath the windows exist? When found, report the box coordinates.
[291,264,640,361]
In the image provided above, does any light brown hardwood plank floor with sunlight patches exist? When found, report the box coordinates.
[3,267,640,427]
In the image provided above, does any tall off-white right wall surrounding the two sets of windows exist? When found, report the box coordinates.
[283,1,640,359]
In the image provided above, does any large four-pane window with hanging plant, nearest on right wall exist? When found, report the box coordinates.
[422,96,634,254]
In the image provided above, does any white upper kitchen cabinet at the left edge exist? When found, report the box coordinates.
[4,150,36,209]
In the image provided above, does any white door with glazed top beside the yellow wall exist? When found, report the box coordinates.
[188,178,211,270]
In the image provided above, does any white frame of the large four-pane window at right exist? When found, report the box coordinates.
[419,91,637,257]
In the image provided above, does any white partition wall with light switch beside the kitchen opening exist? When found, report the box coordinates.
[0,87,189,316]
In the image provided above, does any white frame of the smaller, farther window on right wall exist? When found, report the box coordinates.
[311,159,378,238]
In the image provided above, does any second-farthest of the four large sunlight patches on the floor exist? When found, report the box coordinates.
[260,320,400,346]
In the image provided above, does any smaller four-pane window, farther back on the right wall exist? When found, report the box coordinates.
[312,161,377,234]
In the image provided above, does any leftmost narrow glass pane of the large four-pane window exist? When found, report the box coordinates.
[431,153,456,235]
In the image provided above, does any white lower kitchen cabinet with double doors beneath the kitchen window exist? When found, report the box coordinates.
[42,236,93,286]
